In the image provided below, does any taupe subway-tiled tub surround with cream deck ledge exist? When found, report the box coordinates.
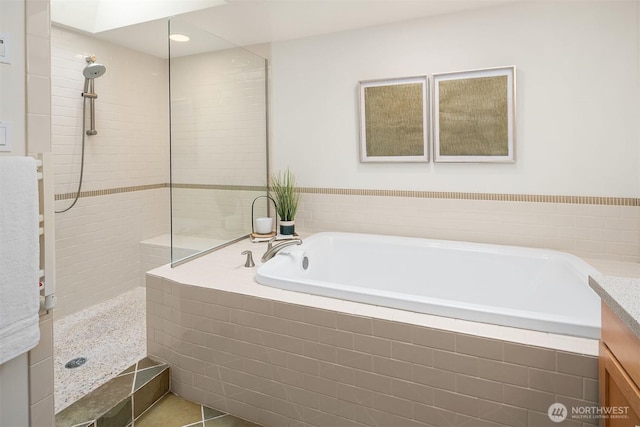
[147,241,598,427]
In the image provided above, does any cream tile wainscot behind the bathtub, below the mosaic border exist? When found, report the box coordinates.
[296,189,640,262]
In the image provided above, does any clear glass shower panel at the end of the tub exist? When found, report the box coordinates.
[169,18,268,264]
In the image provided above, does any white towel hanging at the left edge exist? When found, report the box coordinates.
[0,156,40,365]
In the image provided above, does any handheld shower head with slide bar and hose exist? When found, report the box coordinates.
[56,55,107,213]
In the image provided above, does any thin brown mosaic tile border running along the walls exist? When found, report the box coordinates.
[55,183,640,206]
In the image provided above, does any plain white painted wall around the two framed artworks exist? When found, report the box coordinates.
[271,1,640,197]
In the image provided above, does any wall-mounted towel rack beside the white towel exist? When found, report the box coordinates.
[31,153,56,310]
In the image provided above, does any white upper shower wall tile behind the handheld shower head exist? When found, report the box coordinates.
[51,26,169,194]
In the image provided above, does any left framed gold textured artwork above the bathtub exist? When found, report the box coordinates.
[359,76,429,162]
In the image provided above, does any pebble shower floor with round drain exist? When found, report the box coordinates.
[53,287,147,413]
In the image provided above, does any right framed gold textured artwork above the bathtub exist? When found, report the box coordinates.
[432,66,516,163]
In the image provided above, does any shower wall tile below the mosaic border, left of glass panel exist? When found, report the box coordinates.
[54,188,169,318]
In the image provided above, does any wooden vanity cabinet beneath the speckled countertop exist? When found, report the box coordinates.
[598,302,640,427]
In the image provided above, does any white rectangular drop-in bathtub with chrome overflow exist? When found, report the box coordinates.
[256,233,600,339]
